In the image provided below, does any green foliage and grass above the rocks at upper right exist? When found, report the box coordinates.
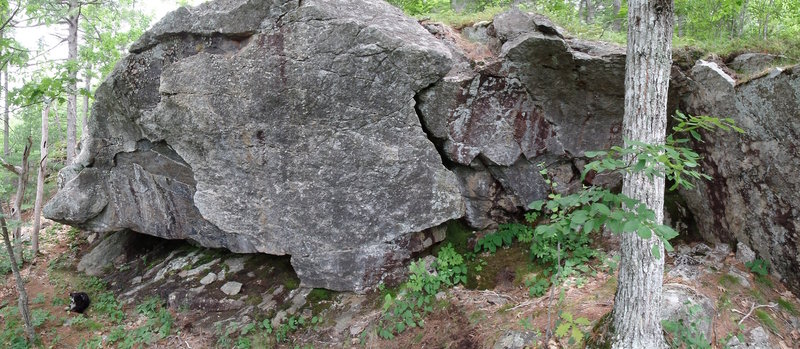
[389,0,800,58]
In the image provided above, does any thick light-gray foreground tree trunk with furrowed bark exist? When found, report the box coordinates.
[613,0,673,348]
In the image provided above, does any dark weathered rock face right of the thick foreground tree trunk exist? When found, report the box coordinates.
[682,61,800,294]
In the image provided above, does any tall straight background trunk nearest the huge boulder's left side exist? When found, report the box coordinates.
[66,0,80,165]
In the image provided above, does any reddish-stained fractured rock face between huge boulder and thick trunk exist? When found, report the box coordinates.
[418,10,625,229]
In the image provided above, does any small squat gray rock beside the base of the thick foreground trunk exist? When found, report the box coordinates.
[661,284,716,340]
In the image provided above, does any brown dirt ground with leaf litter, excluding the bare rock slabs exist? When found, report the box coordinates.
[0,222,800,348]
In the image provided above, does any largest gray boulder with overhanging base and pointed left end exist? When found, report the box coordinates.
[44,0,464,291]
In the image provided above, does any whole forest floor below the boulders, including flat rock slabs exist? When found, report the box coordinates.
[0,218,800,348]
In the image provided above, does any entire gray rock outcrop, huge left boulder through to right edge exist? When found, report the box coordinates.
[44,0,800,293]
